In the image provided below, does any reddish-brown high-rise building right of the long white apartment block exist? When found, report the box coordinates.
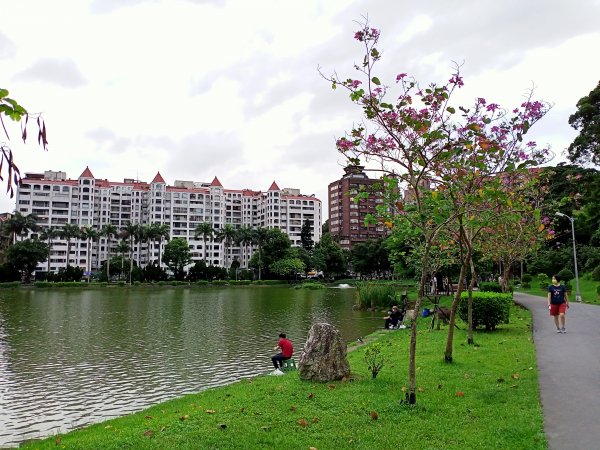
[328,165,389,249]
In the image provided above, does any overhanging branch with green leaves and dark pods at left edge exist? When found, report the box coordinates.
[0,88,48,198]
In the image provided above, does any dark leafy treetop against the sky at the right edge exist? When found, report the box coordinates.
[568,82,600,165]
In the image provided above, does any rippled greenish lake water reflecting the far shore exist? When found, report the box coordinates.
[0,287,382,447]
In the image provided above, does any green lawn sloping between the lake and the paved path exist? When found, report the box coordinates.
[23,307,547,450]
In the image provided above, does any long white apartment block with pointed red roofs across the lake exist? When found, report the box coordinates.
[16,167,322,272]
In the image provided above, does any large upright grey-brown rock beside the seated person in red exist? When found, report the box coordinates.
[298,323,350,382]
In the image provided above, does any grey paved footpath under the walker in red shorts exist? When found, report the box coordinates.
[514,292,600,450]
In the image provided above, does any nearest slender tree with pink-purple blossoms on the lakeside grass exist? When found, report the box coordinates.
[324,23,548,404]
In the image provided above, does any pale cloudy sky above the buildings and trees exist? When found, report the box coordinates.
[0,0,600,218]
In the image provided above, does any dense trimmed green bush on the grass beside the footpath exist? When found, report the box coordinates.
[458,292,513,331]
